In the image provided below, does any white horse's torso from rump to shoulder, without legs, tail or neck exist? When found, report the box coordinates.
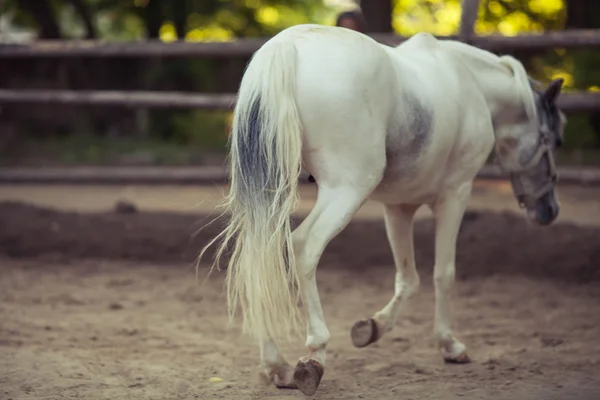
[251,25,486,202]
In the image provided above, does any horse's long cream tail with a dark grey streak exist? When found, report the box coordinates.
[205,39,302,339]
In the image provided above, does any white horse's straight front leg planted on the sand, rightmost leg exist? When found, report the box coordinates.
[432,182,472,363]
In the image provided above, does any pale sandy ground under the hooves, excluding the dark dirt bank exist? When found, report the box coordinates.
[0,259,600,400]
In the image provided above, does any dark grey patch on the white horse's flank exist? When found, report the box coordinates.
[387,93,433,176]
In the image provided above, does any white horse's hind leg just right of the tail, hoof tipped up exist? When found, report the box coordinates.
[293,179,377,396]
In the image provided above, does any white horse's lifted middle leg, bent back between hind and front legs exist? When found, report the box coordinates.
[351,205,419,347]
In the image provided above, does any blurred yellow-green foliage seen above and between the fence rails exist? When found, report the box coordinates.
[0,0,600,163]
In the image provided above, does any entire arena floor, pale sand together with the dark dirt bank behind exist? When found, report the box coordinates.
[0,193,600,400]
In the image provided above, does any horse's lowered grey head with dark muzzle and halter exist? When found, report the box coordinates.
[496,79,566,225]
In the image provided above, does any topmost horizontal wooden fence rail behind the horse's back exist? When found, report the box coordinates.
[0,29,600,59]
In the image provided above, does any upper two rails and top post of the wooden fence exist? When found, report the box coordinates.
[0,0,600,184]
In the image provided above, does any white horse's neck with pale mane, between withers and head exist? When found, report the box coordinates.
[442,41,531,123]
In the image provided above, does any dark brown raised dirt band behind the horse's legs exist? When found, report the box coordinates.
[0,198,600,283]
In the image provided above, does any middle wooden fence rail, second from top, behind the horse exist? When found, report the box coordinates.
[0,89,600,113]
